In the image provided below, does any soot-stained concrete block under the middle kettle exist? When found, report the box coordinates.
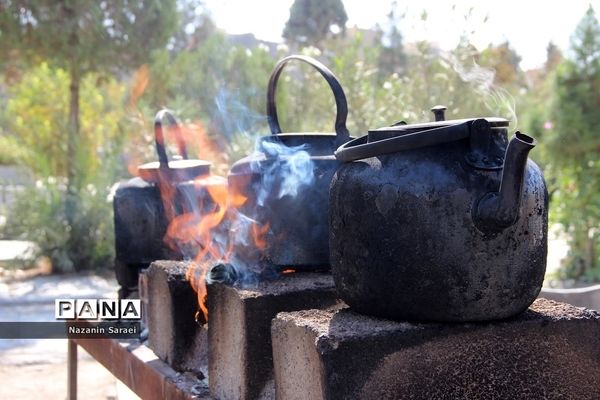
[208,272,337,400]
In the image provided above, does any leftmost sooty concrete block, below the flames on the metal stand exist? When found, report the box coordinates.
[142,261,208,376]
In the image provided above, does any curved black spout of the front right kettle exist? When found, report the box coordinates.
[474,132,536,231]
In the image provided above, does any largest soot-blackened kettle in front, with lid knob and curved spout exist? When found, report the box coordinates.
[330,106,548,321]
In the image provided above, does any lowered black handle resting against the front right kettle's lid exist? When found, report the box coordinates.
[335,122,471,162]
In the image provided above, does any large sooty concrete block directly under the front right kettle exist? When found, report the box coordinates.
[272,299,600,400]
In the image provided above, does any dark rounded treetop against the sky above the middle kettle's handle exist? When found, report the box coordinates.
[283,0,348,47]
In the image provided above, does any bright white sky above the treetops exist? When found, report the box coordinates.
[205,0,600,69]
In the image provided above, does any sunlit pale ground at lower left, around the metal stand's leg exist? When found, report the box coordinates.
[0,258,137,400]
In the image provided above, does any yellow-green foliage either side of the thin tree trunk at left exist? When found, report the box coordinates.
[0,63,125,179]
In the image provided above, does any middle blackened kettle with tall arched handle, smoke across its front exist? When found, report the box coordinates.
[228,55,350,270]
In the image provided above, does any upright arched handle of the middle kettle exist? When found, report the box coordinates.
[267,55,350,146]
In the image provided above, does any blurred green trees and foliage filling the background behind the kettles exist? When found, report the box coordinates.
[0,0,600,279]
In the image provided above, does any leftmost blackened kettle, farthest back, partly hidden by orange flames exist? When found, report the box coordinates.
[113,110,226,297]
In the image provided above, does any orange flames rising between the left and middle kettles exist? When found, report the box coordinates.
[127,65,269,321]
